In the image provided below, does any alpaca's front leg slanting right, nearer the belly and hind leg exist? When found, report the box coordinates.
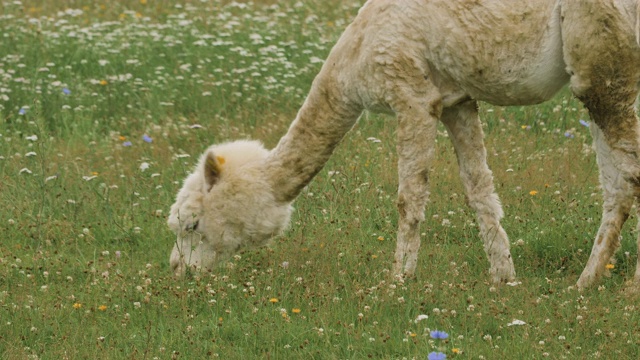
[442,101,516,283]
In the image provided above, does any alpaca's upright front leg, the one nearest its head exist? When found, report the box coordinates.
[393,97,441,276]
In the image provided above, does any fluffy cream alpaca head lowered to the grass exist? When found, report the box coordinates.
[168,141,292,276]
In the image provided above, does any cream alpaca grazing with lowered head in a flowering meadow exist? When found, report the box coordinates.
[169,0,640,287]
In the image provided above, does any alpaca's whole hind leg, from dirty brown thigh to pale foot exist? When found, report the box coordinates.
[561,1,640,288]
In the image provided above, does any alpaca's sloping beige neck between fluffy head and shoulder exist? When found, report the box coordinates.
[266,79,362,202]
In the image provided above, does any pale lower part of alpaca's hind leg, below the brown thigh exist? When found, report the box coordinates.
[577,124,638,288]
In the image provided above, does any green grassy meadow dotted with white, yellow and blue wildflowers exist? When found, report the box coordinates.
[0,0,640,359]
